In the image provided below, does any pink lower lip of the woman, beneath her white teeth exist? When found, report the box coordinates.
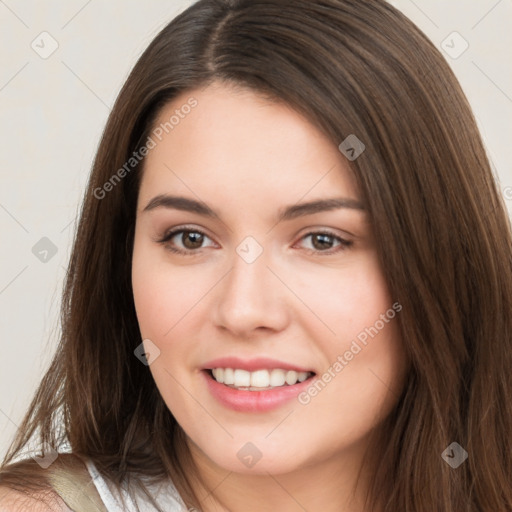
[201,371,314,412]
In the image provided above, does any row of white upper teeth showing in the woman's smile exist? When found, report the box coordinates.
[212,368,312,391]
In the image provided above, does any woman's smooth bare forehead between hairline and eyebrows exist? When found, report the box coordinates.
[140,83,357,210]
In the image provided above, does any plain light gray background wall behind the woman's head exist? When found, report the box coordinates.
[0,0,512,457]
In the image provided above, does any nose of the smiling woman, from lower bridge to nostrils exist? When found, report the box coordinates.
[213,246,290,338]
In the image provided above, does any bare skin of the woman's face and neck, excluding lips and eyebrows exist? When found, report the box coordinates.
[132,83,406,512]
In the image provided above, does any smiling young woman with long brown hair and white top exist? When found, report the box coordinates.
[0,0,512,512]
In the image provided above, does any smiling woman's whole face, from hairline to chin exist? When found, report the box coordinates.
[132,84,405,474]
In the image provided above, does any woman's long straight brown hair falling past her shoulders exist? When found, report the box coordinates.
[0,0,512,512]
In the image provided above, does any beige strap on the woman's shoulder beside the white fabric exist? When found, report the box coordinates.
[50,467,108,512]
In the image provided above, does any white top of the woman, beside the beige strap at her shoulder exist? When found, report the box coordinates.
[85,460,188,512]
